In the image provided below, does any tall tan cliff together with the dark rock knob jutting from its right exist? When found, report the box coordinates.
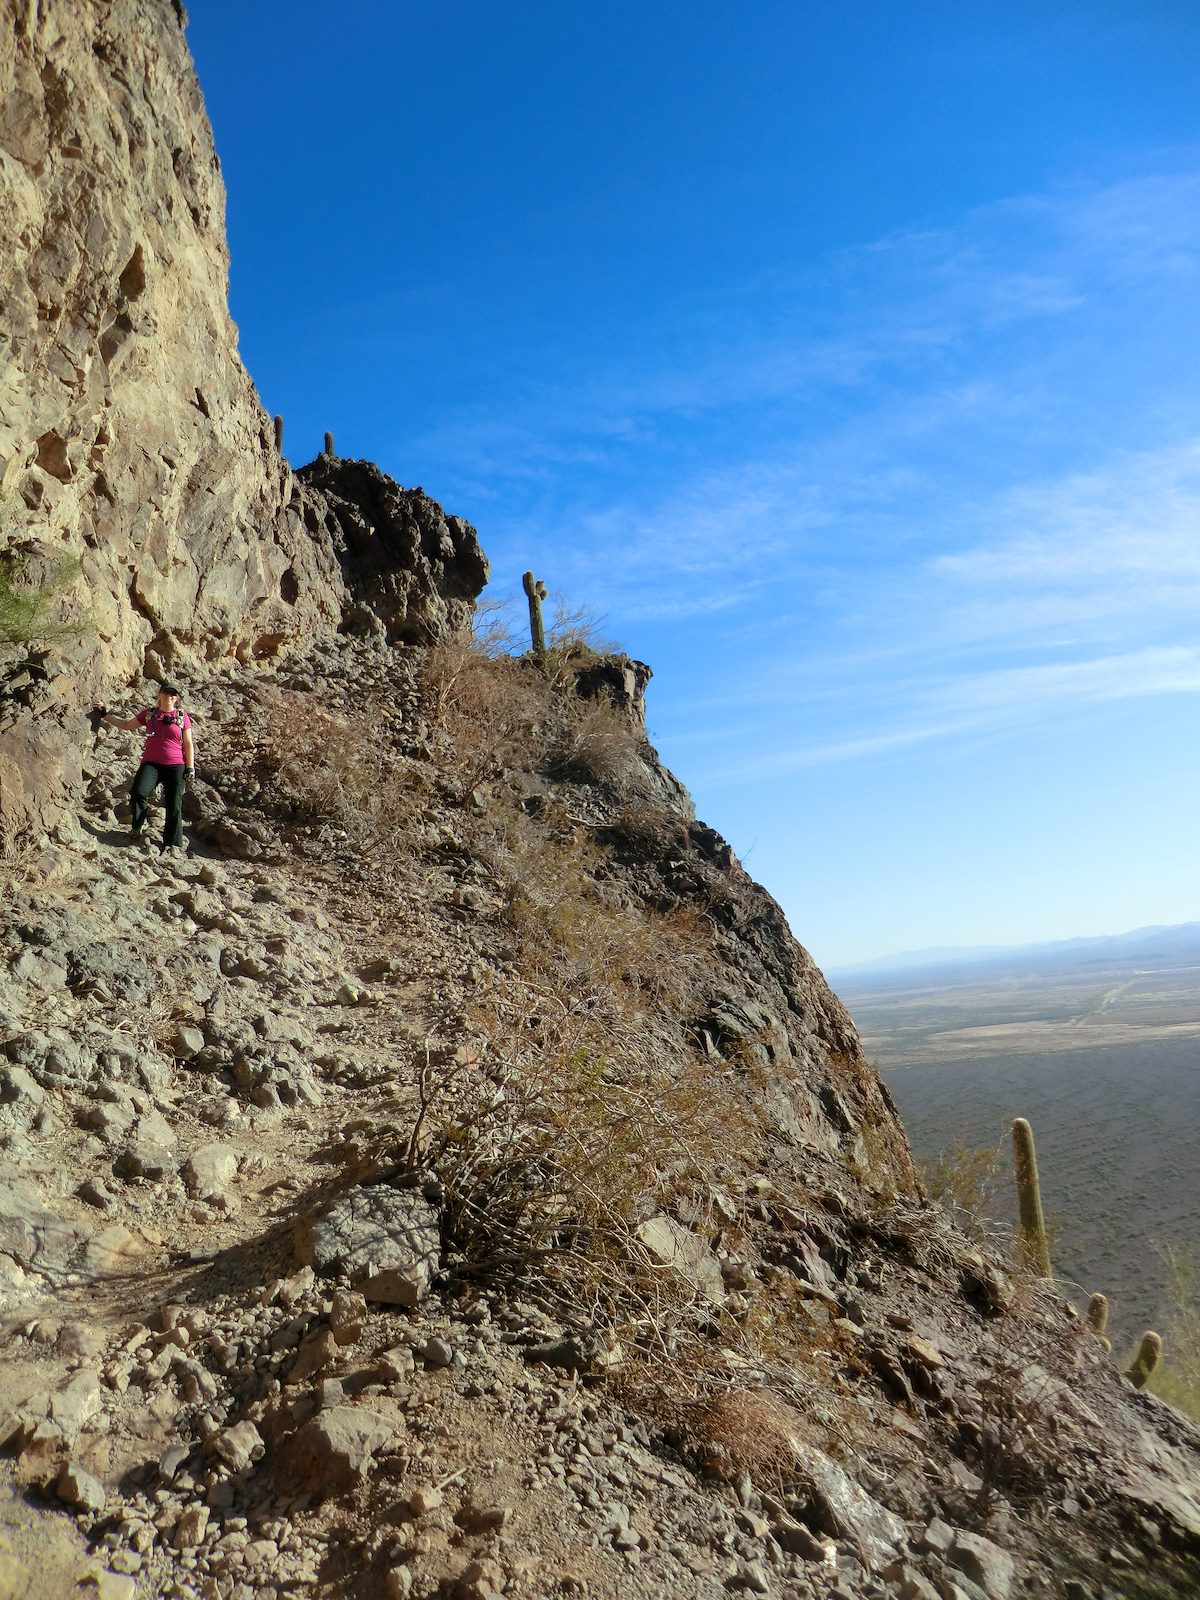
[0,0,486,838]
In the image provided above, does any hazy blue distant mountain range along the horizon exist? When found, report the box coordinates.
[826,922,1200,986]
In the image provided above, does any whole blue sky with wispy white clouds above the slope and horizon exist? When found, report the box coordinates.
[189,0,1200,968]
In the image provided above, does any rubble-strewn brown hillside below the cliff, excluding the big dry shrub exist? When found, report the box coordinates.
[0,637,1200,1600]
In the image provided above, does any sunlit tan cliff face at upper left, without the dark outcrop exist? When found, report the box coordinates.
[0,0,342,675]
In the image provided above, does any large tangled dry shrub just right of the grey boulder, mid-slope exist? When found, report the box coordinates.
[410,972,752,1350]
